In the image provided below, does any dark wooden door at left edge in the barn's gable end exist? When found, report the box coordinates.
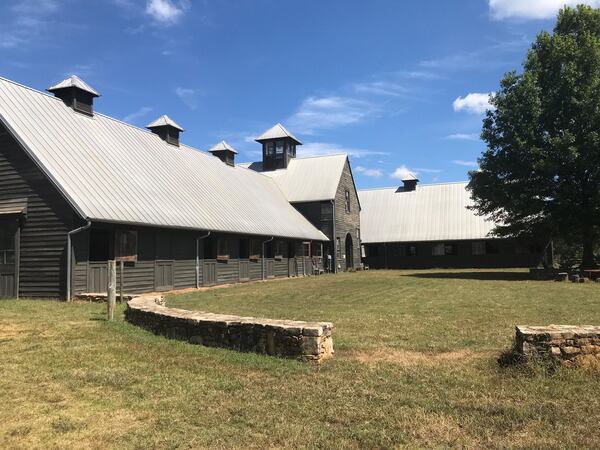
[0,218,19,298]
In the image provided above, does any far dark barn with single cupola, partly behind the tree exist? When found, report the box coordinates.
[359,174,552,269]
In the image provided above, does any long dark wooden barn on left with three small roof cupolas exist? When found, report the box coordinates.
[0,76,329,298]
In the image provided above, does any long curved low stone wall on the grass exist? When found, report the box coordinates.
[125,294,333,361]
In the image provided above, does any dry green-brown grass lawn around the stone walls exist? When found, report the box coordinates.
[0,271,600,448]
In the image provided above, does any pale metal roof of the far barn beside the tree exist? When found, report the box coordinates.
[358,182,494,243]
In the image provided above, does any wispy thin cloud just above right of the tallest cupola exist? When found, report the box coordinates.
[287,96,375,134]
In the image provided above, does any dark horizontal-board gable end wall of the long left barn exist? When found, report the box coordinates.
[0,124,79,298]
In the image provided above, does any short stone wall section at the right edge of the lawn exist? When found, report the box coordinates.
[516,325,600,366]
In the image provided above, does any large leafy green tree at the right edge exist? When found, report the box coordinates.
[469,6,600,268]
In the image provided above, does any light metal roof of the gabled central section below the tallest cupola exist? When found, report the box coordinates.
[241,153,348,203]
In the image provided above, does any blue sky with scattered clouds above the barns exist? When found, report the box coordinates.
[0,0,600,188]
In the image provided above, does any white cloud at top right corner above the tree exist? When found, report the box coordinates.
[489,0,600,20]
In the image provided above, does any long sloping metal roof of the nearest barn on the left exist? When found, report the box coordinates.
[0,78,327,241]
